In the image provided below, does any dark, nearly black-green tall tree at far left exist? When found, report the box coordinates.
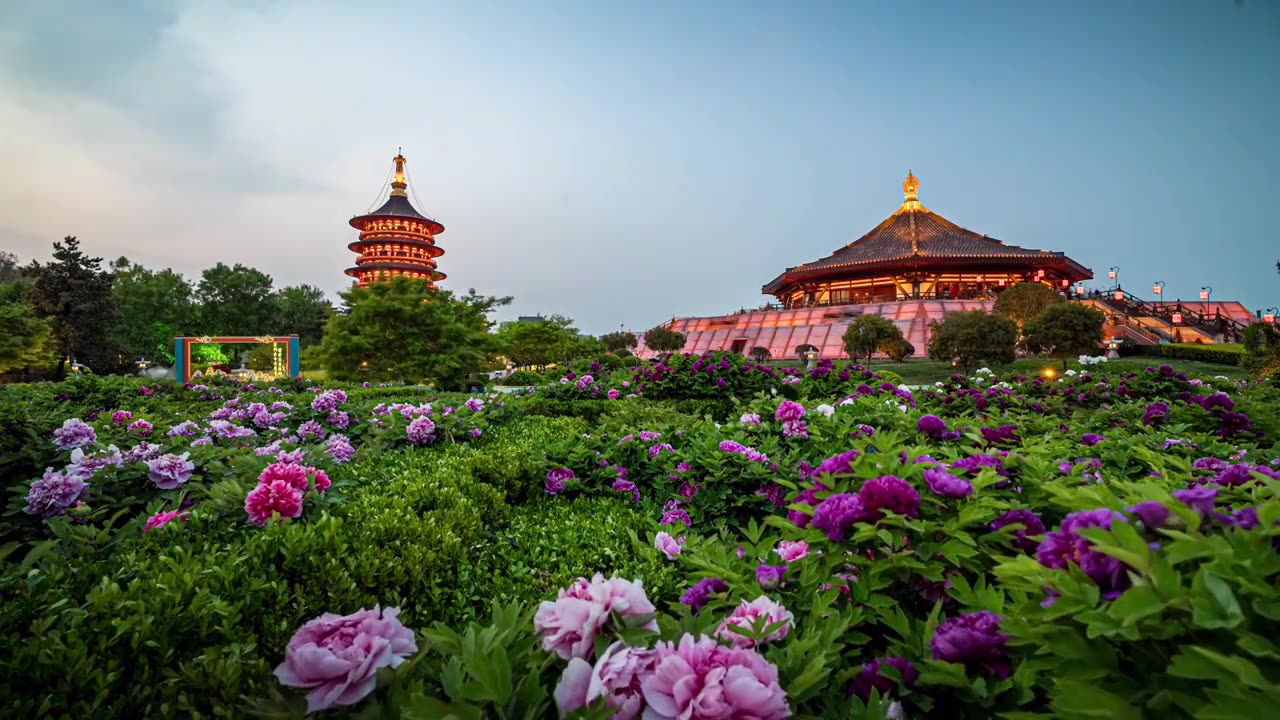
[24,236,120,377]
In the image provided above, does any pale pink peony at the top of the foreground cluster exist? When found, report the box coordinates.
[534,573,658,660]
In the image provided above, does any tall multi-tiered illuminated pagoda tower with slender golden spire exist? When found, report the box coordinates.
[346,152,445,287]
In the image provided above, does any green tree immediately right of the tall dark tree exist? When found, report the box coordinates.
[111,258,198,361]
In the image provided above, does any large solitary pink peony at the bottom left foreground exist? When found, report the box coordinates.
[275,605,417,712]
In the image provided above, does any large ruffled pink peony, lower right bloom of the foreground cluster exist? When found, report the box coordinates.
[640,634,791,720]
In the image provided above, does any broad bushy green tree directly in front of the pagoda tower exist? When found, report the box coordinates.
[319,278,511,389]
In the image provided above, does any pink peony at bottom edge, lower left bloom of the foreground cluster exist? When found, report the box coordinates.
[556,641,655,720]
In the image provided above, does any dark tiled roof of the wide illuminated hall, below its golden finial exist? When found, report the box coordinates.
[787,209,1062,274]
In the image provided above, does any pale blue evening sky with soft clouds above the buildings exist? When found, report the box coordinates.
[0,0,1280,333]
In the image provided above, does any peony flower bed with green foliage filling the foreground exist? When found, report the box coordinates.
[0,357,1280,717]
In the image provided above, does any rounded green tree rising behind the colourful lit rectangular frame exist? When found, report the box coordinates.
[196,263,278,337]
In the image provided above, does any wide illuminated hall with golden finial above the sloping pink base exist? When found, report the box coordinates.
[762,172,1093,307]
